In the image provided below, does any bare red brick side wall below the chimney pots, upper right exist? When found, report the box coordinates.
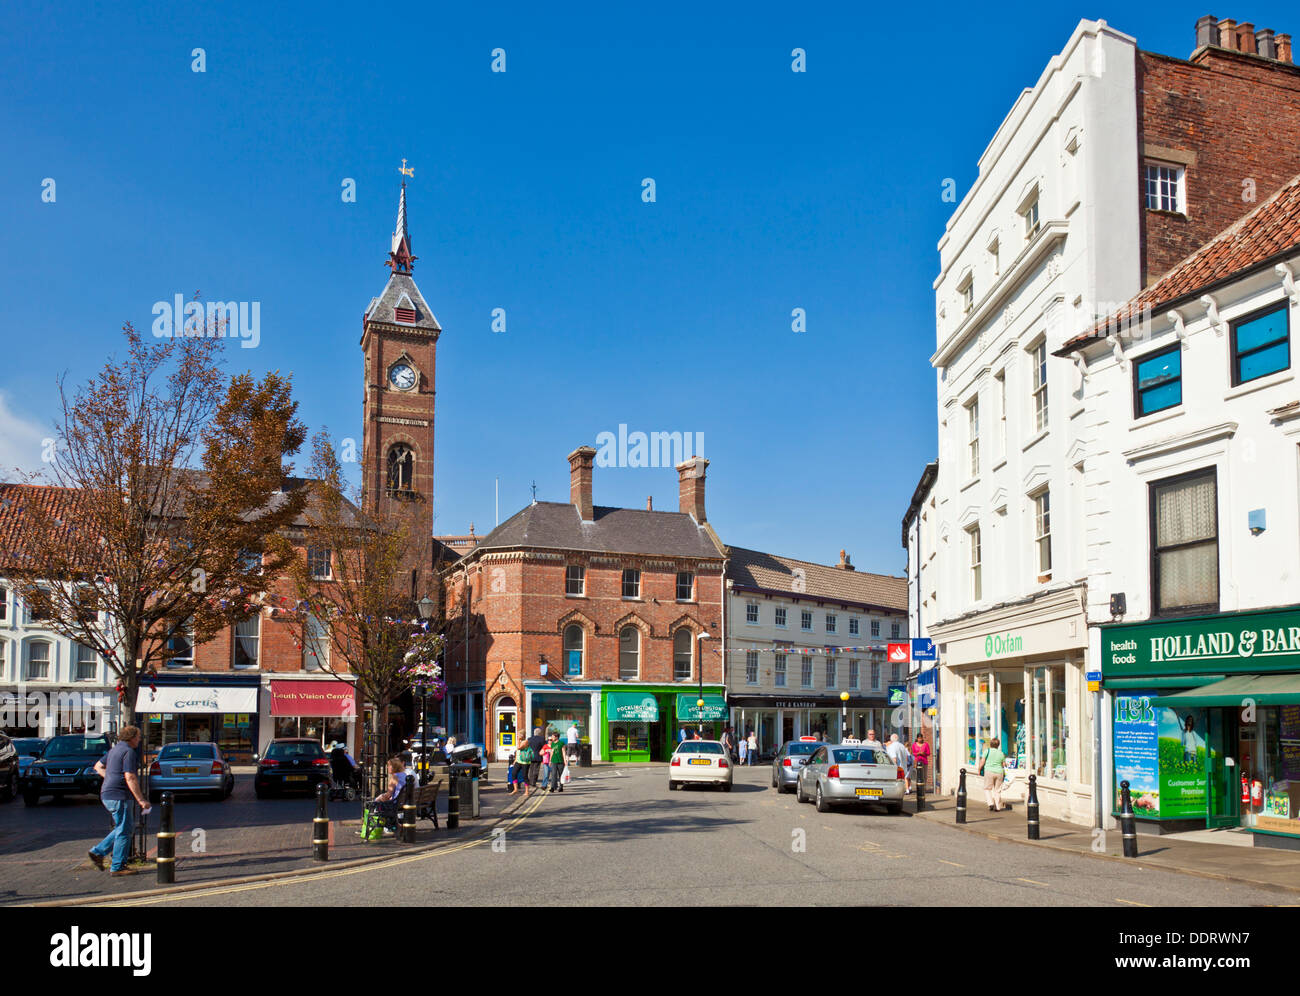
[1138,48,1300,286]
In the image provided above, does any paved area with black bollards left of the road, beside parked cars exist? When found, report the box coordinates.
[0,768,533,905]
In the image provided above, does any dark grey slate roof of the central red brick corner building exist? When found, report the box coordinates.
[454,502,723,560]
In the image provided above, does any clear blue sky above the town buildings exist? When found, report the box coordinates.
[0,3,1300,573]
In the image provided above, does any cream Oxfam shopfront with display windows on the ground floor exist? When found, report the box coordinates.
[931,592,1095,824]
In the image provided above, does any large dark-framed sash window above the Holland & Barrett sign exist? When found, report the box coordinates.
[1151,468,1218,615]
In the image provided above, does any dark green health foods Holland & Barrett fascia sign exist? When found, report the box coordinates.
[1101,609,1300,677]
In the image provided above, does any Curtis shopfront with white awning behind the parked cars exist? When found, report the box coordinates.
[135,675,260,763]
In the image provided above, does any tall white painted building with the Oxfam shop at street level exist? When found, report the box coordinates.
[927,21,1140,822]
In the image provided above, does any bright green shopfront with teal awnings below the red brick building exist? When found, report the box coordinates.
[601,684,727,762]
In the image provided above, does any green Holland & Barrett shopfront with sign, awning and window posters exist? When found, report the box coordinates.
[1101,606,1300,846]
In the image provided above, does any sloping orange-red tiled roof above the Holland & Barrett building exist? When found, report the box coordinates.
[1056,176,1300,356]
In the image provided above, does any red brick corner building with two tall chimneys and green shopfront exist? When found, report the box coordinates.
[443,446,725,761]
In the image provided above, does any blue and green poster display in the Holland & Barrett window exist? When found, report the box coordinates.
[1114,692,1208,819]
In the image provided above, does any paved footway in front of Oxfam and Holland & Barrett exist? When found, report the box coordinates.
[905,796,1300,892]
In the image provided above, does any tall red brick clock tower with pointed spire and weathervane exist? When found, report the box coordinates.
[361,181,442,569]
